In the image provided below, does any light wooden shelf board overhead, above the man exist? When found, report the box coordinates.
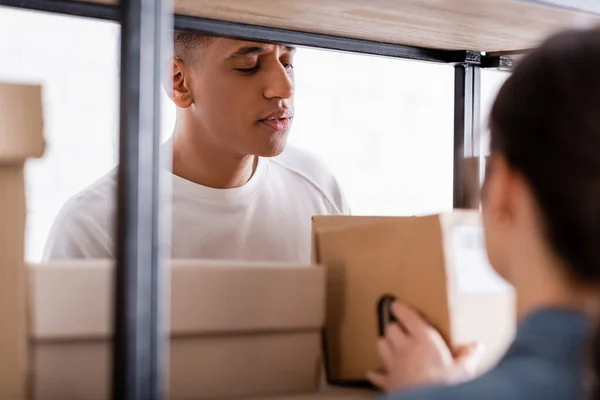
[88,0,600,52]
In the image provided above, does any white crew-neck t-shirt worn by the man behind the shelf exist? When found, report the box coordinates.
[44,147,349,263]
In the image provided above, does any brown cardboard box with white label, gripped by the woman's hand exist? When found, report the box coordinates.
[313,211,516,383]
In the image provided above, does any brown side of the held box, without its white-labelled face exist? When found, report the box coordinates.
[316,216,451,380]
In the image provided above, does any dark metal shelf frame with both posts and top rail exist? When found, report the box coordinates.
[0,0,512,400]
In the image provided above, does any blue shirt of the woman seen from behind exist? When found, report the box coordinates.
[384,309,593,400]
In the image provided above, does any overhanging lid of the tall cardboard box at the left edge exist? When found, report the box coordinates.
[0,83,45,163]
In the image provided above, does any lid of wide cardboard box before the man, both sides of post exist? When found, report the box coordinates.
[29,260,325,339]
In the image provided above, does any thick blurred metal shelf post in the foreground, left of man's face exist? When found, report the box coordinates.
[113,0,172,400]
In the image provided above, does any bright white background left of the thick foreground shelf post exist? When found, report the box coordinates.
[0,8,119,262]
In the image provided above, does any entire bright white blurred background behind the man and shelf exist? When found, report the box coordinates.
[0,7,508,262]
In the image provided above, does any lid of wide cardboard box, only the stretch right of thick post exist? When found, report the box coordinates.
[171,261,325,333]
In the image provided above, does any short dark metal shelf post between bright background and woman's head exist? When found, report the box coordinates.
[453,64,481,208]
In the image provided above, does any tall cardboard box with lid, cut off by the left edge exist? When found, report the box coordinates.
[0,83,44,400]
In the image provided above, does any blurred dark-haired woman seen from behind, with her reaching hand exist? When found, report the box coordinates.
[369,29,600,400]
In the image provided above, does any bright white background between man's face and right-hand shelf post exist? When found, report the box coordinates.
[291,49,454,215]
